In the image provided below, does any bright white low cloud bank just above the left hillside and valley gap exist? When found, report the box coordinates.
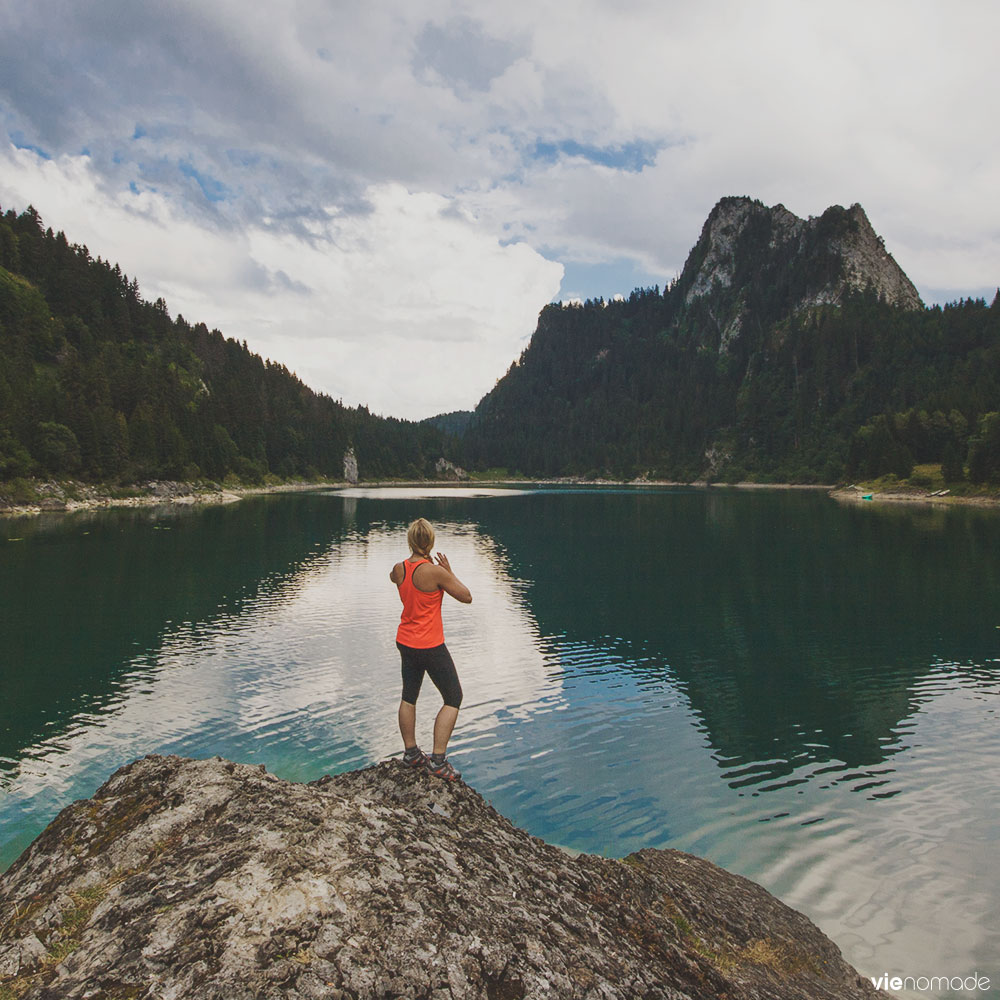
[0,147,562,419]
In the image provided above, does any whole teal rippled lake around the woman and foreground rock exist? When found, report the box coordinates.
[0,487,1000,996]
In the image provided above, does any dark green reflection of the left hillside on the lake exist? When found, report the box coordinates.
[0,498,340,779]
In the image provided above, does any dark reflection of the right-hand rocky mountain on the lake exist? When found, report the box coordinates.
[472,493,998,782]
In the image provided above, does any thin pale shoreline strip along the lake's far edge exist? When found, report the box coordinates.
[0,476,1000,517]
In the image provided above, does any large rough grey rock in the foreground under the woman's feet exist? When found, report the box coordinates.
[0,757,884,1000]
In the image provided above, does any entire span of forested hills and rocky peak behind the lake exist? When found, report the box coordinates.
[7,199,1000,492]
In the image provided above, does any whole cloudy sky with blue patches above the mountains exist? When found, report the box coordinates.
[0,0,1000,419]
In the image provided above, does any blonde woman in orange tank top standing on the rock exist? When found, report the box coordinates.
[389,517,472,781]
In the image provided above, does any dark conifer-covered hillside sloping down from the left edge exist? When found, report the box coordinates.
[0,208,450,483]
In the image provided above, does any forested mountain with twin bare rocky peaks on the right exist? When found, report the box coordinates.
[465,199,1000,482]
